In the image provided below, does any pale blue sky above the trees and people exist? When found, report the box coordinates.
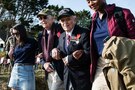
[48,0,135,16]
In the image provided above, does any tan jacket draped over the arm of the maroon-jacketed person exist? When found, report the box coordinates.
[102,36,135,90]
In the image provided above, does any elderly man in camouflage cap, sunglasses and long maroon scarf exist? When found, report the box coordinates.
[37,9,64,90]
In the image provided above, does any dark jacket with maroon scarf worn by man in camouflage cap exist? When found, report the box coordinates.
[38,23,64,80]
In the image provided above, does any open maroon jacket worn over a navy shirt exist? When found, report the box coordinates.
[90,4,135,81]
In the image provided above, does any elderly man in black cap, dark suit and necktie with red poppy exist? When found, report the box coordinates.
[52,8,91,90]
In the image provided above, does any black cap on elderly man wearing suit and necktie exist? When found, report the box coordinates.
[58,8,75,20]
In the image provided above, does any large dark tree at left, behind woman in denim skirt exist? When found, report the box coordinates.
[0,0,48,39]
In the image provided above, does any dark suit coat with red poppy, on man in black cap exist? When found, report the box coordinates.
[58,26,91,90]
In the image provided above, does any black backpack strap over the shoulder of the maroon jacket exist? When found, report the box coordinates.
[114,7,128,37]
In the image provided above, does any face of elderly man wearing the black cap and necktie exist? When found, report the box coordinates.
[59,16,76,32]
